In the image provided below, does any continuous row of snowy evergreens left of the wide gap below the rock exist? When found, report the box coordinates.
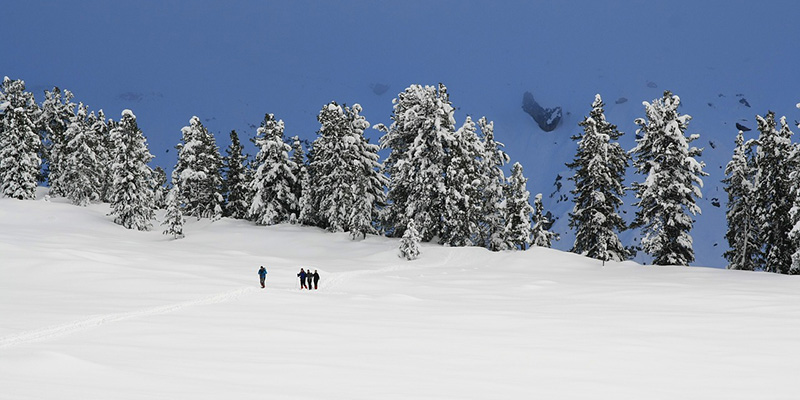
[0,77,556,258]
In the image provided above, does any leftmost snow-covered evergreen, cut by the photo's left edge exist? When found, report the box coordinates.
[0,77,42,199]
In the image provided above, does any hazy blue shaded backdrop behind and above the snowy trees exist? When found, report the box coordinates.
[0,0,800,268]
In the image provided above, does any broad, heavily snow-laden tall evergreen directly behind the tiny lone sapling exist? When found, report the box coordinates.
[381,84,455,241]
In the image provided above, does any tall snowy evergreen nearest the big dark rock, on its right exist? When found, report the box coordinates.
[567,94,629,261]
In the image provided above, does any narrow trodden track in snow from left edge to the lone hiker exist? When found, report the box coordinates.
[0,287,256,349]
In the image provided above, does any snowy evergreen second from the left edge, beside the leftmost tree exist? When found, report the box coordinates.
[38,87,74,196]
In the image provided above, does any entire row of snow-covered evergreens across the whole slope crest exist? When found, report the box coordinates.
[0,74,800,273]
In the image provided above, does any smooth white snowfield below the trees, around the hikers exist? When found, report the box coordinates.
[0,193,800,400]
